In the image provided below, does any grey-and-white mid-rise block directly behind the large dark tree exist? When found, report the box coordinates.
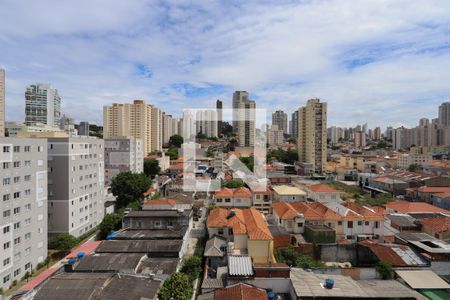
[104,137,144,186]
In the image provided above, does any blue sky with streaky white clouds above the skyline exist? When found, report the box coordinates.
[0,0,450,128]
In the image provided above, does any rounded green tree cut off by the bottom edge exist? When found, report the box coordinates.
[158,272,193,300]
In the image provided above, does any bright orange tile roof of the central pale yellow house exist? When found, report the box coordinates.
[208,208,273,240]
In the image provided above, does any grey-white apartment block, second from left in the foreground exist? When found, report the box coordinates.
[47,136,105,237]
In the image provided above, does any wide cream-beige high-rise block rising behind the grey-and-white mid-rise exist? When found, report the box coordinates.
[103,100,162,153]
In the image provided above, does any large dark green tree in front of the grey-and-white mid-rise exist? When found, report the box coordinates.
[111,172,152,208]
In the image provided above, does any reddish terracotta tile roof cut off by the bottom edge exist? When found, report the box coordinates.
[214,283,268,300]
